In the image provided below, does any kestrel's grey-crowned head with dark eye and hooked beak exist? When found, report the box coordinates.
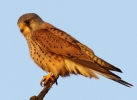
[17,13,43,37]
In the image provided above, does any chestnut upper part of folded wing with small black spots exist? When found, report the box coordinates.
[32,29,90,60]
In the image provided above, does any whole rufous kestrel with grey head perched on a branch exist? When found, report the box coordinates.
[17,13,133,87]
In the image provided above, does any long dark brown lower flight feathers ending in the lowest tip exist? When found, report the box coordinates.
[71,59,133,87]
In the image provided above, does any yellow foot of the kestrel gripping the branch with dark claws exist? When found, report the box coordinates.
[40,72,57,86]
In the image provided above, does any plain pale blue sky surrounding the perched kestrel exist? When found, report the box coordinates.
[0,0,137,100]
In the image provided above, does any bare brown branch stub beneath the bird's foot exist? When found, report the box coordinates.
[30,81,53,100]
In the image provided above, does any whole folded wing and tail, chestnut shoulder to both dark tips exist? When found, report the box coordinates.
[32,29,132,87]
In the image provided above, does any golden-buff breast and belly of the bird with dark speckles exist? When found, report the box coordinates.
[27,39,69,77]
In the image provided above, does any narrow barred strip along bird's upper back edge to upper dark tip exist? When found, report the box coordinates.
[48,27,122,72]
